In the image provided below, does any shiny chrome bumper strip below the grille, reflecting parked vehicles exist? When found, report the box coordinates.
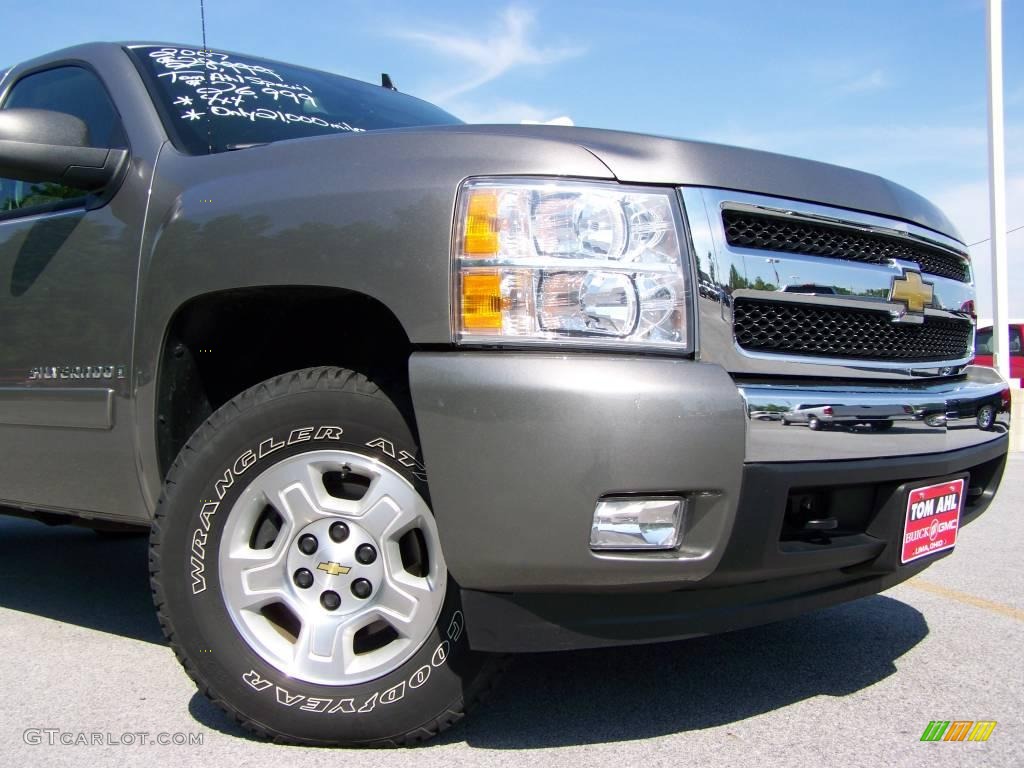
[739,366,1010,462]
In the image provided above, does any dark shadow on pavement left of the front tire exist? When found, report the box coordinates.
[0,516,164,644]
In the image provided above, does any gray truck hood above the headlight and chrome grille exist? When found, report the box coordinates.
[401,125,964,243]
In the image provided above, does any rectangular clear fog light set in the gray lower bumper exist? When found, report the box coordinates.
[590,498,685,550]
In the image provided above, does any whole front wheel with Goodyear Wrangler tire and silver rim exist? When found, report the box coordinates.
[150,368,505,746]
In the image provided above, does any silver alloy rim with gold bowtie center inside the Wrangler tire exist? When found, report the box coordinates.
[218,451,447,686]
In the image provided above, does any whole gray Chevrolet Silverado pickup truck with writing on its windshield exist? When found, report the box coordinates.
[0,43,1010,745]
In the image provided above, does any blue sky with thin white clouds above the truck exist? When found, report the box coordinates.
[8,0,1024,315]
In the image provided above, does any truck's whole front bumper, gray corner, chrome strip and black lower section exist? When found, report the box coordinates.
[410,351,1010,650]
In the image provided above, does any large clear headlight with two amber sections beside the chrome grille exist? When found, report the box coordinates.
[453,179,689,351]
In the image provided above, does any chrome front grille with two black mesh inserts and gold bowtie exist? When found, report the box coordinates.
[681,187,975,379]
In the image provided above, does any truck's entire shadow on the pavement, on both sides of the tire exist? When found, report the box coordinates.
[0,517,928,750]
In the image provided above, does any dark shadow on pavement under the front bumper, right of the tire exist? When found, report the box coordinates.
[442,596,928,762]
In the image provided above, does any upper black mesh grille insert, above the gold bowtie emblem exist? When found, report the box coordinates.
[722,209,970,283]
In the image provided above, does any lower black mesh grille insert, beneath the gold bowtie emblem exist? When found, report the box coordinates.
[733,299,971,362]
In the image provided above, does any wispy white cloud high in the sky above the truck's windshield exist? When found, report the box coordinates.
[394,5,584,103]
